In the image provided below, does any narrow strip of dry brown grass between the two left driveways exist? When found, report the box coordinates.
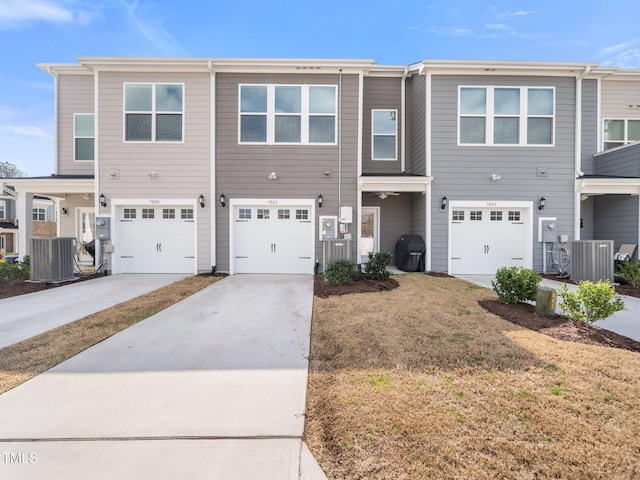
[0,275,221,393]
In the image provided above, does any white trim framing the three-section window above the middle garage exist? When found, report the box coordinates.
[238,83,338,146]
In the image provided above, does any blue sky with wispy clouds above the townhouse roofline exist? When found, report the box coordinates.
[0,0,640,176]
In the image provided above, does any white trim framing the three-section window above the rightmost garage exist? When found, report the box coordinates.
[457,85,557,148]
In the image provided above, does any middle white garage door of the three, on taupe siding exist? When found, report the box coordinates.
[232,205,314,273]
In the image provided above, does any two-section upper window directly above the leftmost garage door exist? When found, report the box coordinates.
[124,83,184,142]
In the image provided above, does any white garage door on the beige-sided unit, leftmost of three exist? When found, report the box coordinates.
[114,205,195,273]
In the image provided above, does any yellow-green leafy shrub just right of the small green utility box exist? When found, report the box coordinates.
[560,281,624,323]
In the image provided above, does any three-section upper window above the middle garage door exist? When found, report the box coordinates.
[239,85,337,145]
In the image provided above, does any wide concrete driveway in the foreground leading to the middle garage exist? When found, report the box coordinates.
[0,275,325,480]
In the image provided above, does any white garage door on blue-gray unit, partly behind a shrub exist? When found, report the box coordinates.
[449,206,531,274]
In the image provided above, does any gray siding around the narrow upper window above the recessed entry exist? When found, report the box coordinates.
[362,77,402,174]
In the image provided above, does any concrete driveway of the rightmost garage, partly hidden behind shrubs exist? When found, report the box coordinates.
[456,275,640,342]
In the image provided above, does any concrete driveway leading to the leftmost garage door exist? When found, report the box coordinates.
[0,274,189,348]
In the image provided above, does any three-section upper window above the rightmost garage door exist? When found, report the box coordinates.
[458,87,555,145]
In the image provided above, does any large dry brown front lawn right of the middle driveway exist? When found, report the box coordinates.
[305,274,640,480]
